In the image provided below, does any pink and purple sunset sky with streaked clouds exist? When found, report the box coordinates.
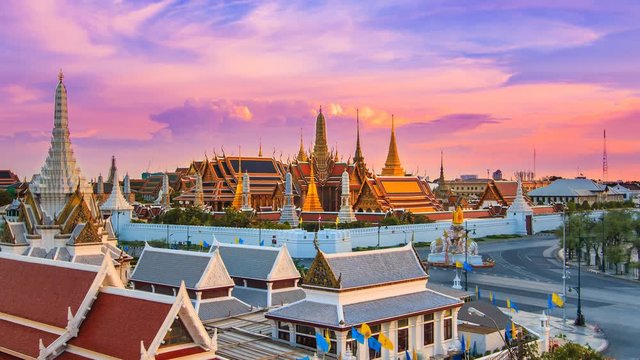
[0,0,640,180]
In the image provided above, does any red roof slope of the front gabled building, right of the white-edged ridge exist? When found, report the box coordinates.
[69,293,172,359]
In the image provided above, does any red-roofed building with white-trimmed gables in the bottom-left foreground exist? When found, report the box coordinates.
[0,252,217,359]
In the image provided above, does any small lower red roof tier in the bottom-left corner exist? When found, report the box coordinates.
[0,320,58,359]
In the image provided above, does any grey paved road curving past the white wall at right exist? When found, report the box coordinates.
[419,236,640,359]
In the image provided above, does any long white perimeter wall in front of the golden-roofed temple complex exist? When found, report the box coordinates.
[118,214,564,258]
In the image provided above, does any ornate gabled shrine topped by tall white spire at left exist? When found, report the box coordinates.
[0,72,132,280]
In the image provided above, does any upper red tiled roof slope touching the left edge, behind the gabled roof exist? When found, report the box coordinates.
[0,258,97,328]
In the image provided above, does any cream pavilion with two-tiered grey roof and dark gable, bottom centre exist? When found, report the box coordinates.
[265,244,463,360]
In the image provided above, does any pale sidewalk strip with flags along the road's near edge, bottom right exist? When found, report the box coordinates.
[500,308,609,352]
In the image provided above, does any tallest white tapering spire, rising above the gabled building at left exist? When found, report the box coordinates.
[29,70,97,219]
